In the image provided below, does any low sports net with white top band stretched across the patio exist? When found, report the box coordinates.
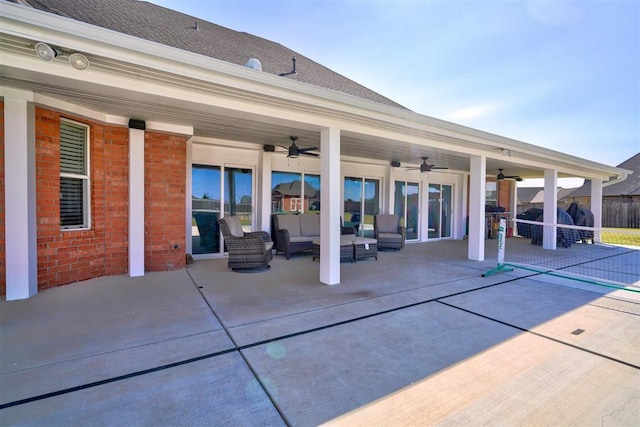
[483,219,640,292]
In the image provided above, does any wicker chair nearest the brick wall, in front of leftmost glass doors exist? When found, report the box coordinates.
[218,216,273,271]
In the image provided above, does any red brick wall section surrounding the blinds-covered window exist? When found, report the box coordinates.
[36,107,128,290]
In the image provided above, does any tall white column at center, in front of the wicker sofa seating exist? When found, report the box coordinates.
[320,128,341,285]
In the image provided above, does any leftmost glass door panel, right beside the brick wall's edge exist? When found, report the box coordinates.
[191,165,221,254]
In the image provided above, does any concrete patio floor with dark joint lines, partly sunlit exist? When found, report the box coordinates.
[0,241,640,426]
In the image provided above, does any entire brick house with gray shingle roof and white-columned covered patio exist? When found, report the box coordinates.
[0,0,628,299]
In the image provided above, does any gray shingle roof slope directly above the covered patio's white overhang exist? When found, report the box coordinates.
[11,0,405,108]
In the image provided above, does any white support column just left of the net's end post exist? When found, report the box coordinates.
[467,156,487,261]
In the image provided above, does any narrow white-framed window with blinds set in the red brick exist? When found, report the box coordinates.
[60,121,90,229]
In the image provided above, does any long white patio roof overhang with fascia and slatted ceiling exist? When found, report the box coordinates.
[0,2,630,182]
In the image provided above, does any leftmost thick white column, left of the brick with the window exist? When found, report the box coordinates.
[4,96,38,301]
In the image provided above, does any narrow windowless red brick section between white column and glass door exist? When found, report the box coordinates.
[144,131,187,271]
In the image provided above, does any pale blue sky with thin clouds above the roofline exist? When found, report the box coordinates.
[153,0,640,165]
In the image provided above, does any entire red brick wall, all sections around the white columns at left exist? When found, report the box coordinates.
[0,106,187,296]
